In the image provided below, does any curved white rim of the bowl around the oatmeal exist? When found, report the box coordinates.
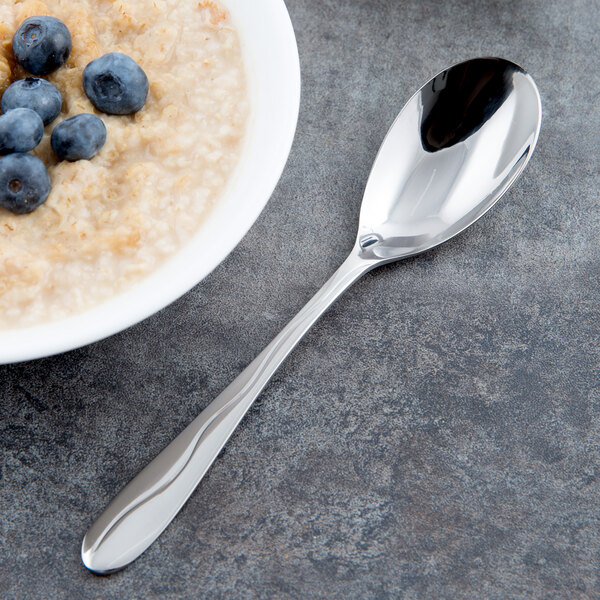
[0,0,300,364]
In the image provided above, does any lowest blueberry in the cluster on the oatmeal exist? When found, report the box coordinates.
[0,154,50,215]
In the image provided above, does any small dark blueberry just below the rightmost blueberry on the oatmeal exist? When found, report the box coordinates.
[51,114,106,162]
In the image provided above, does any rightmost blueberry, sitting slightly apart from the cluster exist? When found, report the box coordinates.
[83,52,148,115]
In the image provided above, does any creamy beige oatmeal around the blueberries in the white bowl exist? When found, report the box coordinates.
[0,0,248,329]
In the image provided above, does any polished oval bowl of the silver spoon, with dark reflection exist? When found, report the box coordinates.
[358,58,542,261]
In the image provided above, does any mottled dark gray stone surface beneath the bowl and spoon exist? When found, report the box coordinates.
[0,0,600,600]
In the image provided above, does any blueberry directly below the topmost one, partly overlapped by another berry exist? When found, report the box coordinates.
[2,77,62,125]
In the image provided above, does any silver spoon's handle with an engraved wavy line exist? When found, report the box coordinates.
[81,251,376,573]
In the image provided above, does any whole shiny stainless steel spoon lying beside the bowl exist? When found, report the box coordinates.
[81,58,542,574]
